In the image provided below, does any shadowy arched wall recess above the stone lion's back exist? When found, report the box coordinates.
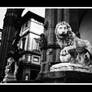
[79,9,92,45]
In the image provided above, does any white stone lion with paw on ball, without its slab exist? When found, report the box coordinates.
[51,21,92,72]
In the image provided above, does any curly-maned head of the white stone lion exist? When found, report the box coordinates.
[55,21,75,47]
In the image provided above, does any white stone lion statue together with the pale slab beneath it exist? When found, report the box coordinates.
[50,21,92,73]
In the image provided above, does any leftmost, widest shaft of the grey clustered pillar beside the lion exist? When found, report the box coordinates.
[44,9,57,73]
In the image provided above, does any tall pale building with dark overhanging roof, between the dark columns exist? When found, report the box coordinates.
[14,11,44,81]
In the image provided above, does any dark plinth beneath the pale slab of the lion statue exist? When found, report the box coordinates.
[38,71,92,83]
